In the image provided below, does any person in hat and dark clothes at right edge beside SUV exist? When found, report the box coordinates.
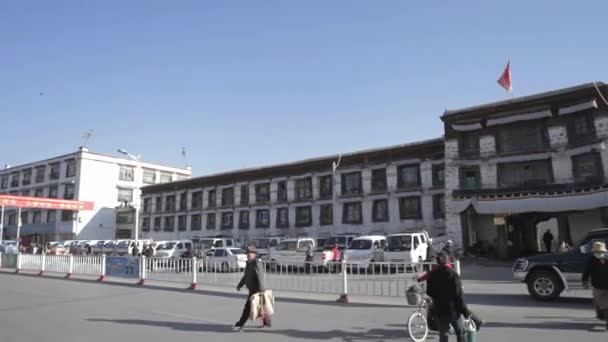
[583,241,608,329]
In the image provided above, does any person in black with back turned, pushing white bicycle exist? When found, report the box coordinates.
[426,253,471,342]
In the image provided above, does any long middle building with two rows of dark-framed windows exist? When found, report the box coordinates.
[140,139,445,240]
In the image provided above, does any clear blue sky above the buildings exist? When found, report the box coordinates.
[0,0,608,175]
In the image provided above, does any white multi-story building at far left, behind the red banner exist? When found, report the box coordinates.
[0,147,191,243]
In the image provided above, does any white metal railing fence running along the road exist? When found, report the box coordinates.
[0,254,460,297]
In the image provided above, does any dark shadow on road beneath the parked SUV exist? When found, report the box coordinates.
[465,293,591,309]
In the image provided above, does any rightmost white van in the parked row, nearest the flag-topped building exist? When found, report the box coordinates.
[384,232,430,263]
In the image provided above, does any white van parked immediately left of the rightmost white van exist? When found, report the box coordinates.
[344,235,386,269]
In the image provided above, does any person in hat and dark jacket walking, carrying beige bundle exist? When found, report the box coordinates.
[234,246,271,329]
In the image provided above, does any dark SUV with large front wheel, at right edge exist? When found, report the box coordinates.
[513,228,608,301]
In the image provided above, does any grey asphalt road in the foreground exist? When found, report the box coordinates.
[0,270,608,342]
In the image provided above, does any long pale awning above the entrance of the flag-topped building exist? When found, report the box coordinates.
[451,189,608,214]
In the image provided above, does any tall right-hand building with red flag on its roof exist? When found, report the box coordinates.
[442,83,608,257]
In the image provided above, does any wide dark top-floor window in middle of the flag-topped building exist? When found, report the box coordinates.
[496,121,549,153]
